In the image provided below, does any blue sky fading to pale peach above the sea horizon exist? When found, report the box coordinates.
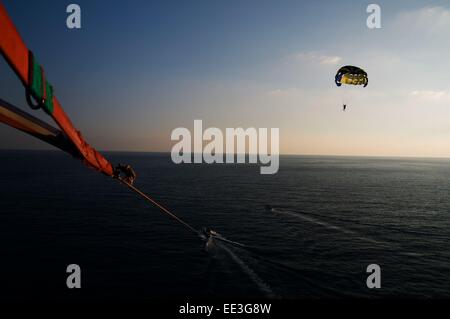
[0,0,450,157]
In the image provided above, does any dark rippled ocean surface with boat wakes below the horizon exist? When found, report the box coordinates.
[0,151,450,300]
